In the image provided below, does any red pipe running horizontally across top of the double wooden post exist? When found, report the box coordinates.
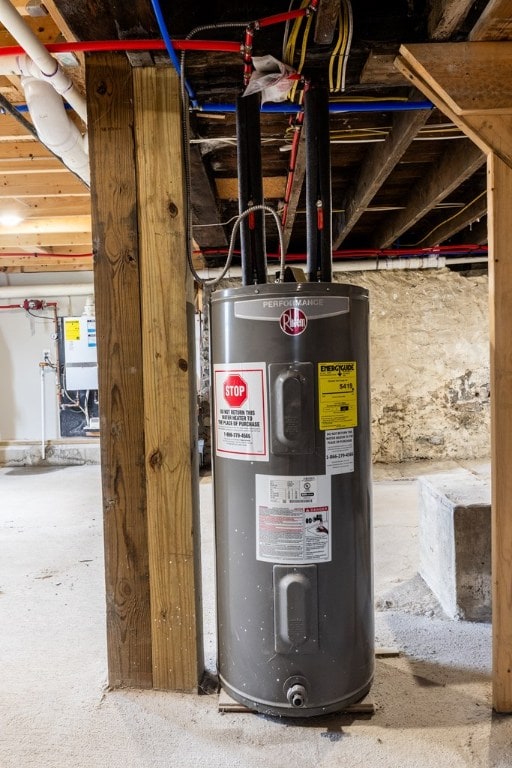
[0,40,241,56]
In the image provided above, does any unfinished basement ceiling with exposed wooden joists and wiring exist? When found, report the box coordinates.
[0,0,512,271]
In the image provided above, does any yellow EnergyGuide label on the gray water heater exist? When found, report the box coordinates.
[318,361,357,430]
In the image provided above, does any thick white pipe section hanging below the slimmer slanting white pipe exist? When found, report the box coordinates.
[21,77,90,185]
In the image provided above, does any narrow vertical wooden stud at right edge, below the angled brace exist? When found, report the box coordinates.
[488,153,512,712]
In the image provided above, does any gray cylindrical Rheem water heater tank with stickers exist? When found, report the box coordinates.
[210,283,374,717]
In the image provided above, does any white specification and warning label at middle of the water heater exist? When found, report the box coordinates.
[256,475,331,565]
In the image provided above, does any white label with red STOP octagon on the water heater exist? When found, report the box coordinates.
[213,363,268,461]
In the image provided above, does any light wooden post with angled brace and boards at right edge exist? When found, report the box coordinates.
[395,39,512,713]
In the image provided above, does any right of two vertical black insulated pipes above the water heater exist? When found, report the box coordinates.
[304,85,332,283]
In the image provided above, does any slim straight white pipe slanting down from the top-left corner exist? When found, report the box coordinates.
[0,0,87,123]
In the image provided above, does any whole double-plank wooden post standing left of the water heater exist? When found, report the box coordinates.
[87,54,202,691]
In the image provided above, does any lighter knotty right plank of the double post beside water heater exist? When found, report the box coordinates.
[133,67,200,691]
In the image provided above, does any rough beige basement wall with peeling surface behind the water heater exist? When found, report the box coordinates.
[200,269,490,463]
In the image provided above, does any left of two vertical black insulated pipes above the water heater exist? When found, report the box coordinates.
[236,93,267,285]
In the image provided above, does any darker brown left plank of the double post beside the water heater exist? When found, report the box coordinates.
[86,54,153,688]
